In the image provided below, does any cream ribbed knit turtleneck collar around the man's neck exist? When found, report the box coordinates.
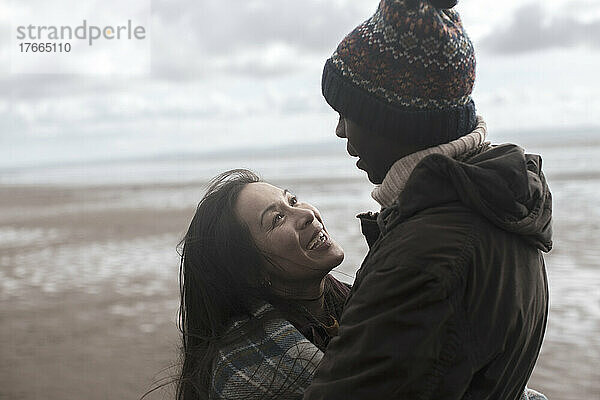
[371,116,487,208]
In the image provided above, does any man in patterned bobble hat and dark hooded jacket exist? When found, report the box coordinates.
[304,0,552,400]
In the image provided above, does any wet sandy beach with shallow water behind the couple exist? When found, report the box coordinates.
[0,151,600,400]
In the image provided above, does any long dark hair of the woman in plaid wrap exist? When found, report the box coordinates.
[177,169,268,400]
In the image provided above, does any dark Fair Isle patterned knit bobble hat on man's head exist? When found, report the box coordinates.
[322,0,476,147]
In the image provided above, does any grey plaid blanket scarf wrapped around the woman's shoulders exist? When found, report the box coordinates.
[209,275,350,400]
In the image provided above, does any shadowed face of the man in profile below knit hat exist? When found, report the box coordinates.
[335,116,408,184]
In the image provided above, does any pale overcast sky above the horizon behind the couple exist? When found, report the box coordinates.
[0,0,600,167]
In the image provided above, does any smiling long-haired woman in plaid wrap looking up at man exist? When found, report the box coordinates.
[171,170,545,400]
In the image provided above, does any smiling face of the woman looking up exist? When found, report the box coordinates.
[235,182,344,281]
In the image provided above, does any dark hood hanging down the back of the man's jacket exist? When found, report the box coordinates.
[390,144,552,252]
